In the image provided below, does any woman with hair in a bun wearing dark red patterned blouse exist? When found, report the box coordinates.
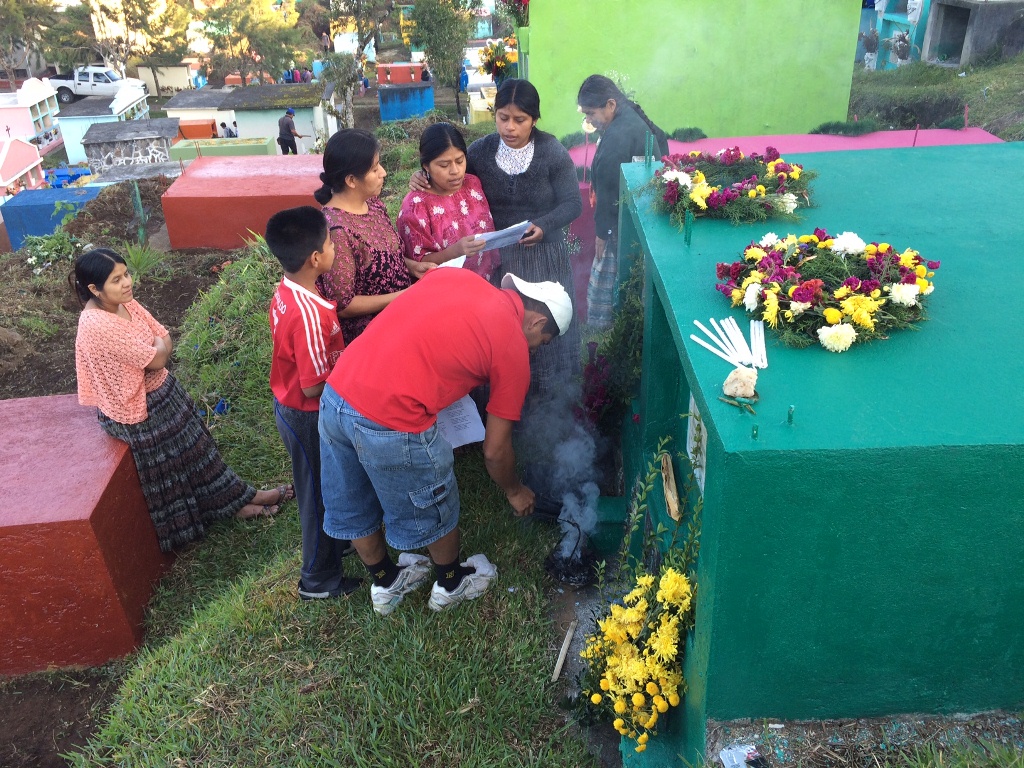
[314,128,436,344]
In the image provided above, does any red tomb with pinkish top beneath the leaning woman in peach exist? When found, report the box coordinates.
[0,395,172,675]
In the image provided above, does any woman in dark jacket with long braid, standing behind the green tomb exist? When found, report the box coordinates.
[577,75,669,329]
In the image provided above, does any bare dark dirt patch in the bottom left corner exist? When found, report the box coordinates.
[0,668,119,768]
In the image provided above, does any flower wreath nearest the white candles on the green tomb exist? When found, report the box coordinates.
[716,229,939,352]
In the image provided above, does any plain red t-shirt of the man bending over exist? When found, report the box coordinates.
[328,267,529,432]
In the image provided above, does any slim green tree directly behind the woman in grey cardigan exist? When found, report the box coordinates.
[413,0,480,115]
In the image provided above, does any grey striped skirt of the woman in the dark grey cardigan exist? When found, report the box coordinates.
[492,240,581,396]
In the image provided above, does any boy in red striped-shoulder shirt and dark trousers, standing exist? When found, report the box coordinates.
[265,206,361,600]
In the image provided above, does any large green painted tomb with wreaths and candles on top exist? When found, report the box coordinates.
[622,144,1024,766]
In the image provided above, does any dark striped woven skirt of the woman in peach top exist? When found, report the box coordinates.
[97,374,256,552]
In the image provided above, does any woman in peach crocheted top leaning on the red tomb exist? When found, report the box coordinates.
[69,248,294,552]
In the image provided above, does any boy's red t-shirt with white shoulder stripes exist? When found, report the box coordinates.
[270,278,345,411]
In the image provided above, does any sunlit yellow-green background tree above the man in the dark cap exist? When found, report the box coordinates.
[203,0,301,83]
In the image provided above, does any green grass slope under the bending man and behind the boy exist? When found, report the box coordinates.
[70,237,593,767]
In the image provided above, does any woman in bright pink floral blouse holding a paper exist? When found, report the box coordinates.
[398,123,501,280]
